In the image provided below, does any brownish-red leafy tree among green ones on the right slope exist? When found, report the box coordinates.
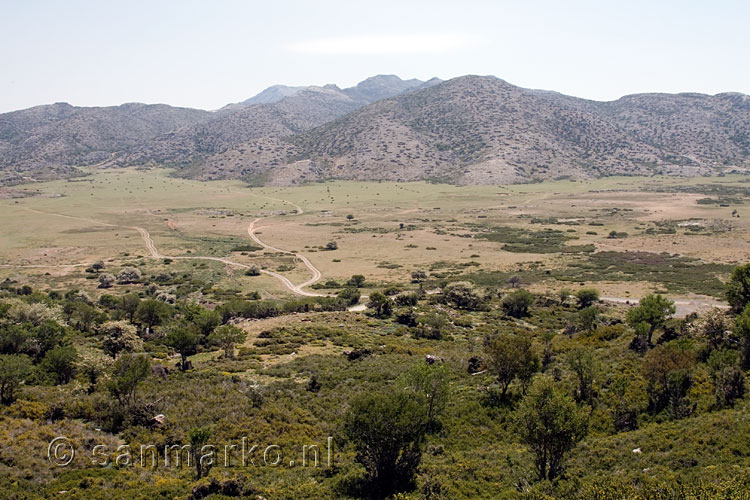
[643,344,695,418]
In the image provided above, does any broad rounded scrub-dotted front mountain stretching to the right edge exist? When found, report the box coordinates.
[195,76,750,184]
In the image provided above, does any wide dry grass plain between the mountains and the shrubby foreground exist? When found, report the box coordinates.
[0,169,750,310]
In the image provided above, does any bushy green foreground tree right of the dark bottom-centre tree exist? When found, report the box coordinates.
[516,376,587,481]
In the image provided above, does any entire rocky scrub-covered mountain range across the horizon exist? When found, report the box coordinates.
[0,75,750,188]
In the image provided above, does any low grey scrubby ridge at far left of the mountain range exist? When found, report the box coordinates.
[0,103,211,184]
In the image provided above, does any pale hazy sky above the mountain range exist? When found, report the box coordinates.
[0,0,750,112]
